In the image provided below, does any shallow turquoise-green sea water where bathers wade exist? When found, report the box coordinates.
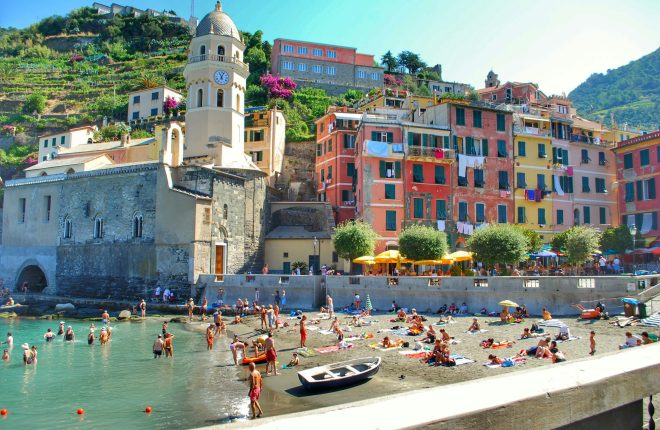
[0,319,249,429]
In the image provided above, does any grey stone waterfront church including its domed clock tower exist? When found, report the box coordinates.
[0,3,270,297]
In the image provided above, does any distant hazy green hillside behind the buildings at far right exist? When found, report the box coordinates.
[569,48,660,130]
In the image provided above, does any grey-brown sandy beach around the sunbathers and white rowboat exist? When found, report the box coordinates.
[228,312,658,416]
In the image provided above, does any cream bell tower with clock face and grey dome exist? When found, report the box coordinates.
[183,1,253,168]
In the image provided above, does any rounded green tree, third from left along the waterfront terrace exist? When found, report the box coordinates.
[467,224,527,265]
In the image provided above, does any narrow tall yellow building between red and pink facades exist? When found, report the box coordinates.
[513,107,553,243]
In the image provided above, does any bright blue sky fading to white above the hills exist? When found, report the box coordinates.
[0,0,660,94]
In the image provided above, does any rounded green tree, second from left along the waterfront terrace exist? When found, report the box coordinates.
[399,224,447,261]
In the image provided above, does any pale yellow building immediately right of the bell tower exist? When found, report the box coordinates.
[245,109,286,186]
